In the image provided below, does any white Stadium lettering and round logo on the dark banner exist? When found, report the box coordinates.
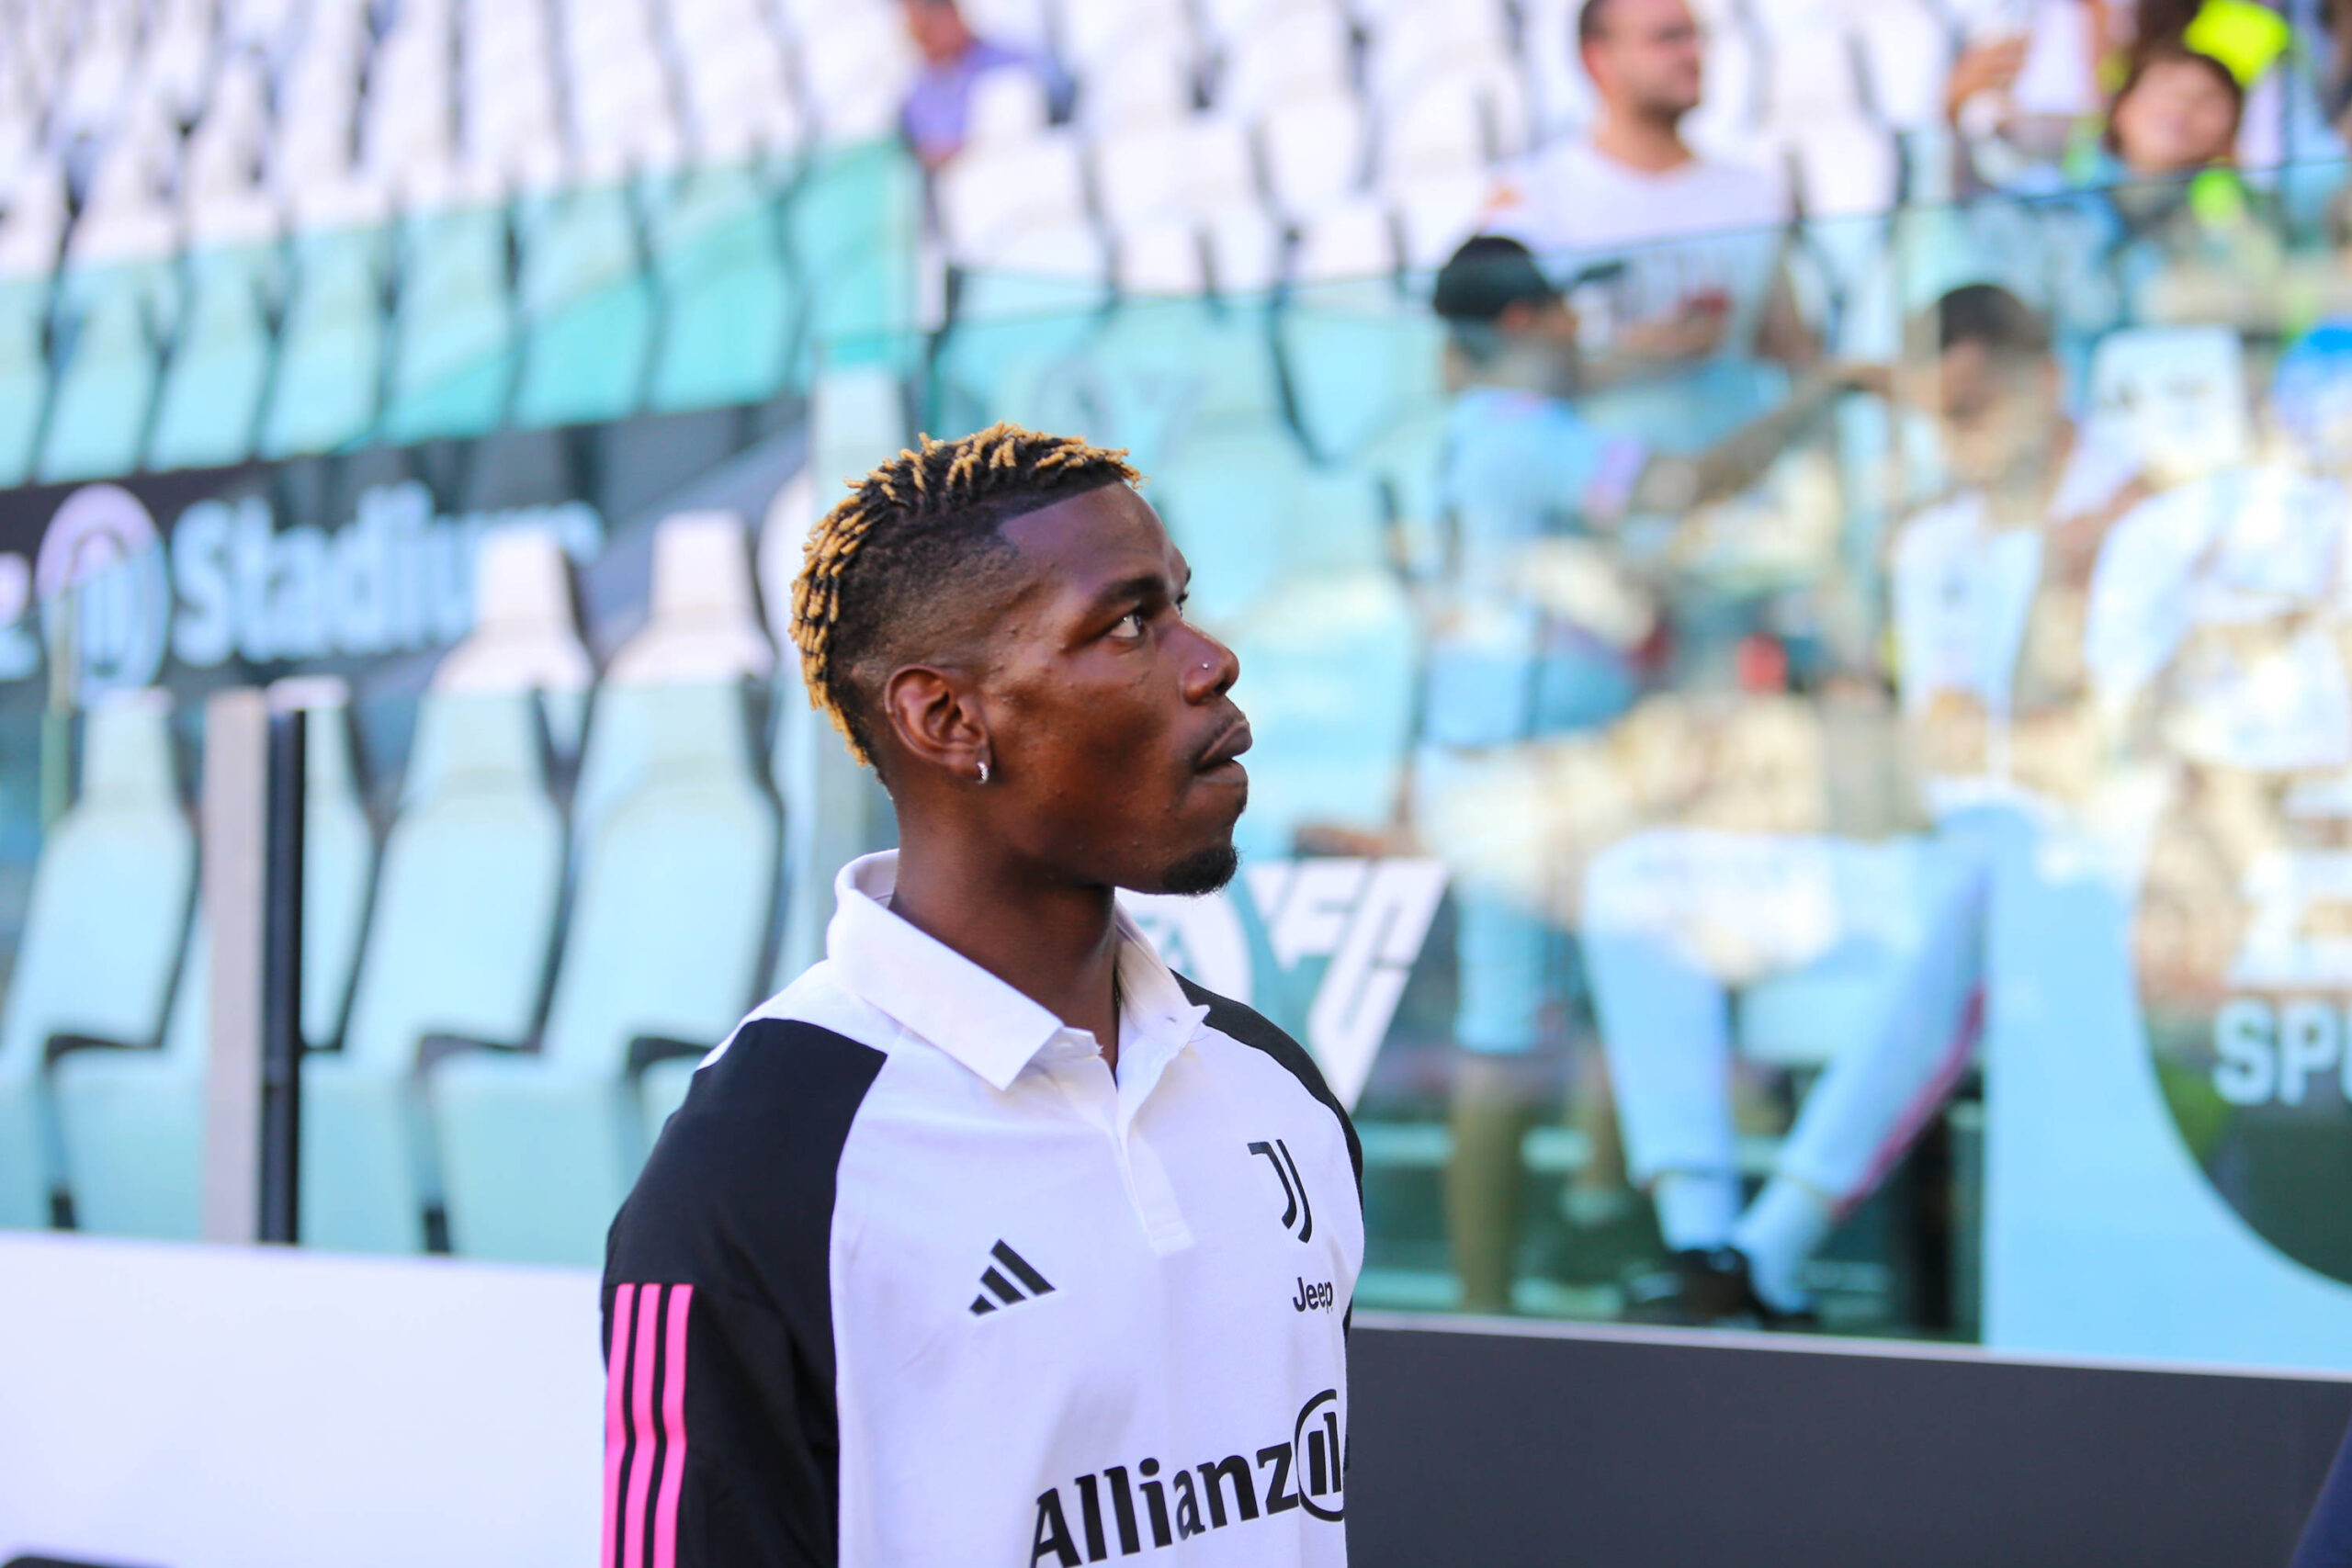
[0,482,605,691]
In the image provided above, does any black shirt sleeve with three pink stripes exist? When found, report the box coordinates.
[605,1021,885,1568]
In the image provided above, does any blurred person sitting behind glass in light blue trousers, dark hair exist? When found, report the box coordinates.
[1585,285,2133,1324]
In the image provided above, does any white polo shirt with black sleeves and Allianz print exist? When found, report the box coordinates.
[605,853,1364,1568]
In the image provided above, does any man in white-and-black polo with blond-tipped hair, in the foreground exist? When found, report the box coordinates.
[605,425,1364,1568]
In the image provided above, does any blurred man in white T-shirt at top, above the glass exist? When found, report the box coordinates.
[1487,0,1818,430]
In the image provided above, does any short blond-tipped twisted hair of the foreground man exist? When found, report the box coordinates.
[793,423,1143,764]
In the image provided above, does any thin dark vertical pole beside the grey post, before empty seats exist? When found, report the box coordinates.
[259,707,308,1246]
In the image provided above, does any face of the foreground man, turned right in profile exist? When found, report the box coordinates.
[981,484,1249,894]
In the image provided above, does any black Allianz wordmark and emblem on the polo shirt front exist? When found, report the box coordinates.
[1030,1389,1348,1568]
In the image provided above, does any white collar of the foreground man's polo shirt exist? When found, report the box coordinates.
[826,849,1209,1090]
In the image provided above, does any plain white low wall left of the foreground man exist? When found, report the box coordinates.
[0,1235,605,1568]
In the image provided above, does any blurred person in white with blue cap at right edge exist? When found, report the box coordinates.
[2084,327,2352,1024]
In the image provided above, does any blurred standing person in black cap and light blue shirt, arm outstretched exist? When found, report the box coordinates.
[1416,235,1853,1312]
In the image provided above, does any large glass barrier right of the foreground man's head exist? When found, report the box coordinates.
[898,174,2352,1363]
